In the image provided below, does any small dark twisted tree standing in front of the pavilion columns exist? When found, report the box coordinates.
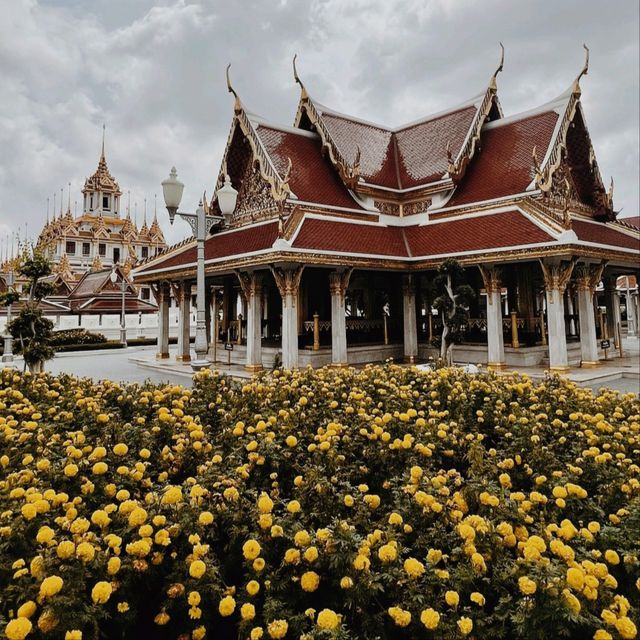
[433,259,476,365]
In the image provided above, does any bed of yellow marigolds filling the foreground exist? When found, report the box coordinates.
[0,365,640,640]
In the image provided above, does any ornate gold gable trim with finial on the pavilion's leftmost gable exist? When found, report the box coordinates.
[211,65,291,207]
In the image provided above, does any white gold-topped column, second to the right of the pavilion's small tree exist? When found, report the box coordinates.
[541,261,575,372]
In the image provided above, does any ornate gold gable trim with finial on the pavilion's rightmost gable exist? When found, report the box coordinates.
[532,45,615,220]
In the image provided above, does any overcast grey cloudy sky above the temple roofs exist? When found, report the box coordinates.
[0,0,639,250]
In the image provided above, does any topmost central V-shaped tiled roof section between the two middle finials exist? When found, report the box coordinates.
[321,106,477,189]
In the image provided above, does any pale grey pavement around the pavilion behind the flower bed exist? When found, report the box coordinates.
[3,338,640,395]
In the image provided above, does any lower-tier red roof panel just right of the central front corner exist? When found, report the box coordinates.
[406,211,554,256]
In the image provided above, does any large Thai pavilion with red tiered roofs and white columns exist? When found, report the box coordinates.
[133,51,640,371]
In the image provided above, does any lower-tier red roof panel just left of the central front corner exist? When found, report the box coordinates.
[293,218,409,257]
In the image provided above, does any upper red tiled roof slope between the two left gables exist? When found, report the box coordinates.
[256,124,362,209]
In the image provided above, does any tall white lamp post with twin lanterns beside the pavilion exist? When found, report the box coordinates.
[162,167,238,369]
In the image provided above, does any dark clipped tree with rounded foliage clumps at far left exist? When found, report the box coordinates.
[8,250,54,373]
